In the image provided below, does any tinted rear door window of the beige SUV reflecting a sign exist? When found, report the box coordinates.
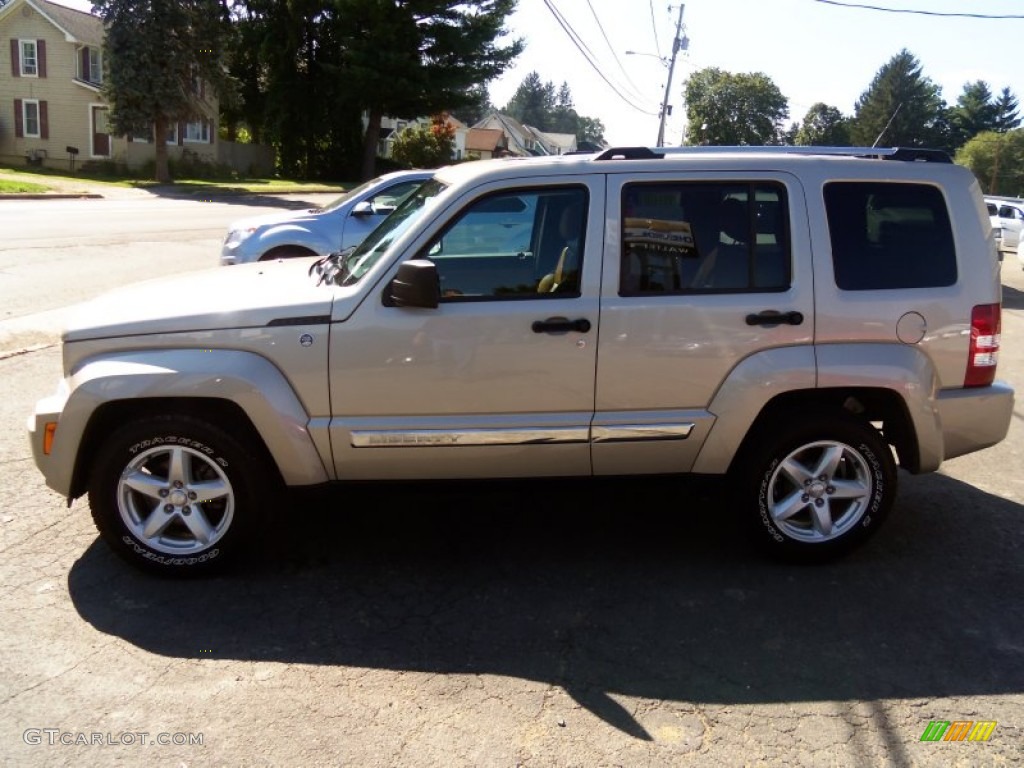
[618,181,791,296]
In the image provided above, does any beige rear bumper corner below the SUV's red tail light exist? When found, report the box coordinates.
[936,381,1014,460]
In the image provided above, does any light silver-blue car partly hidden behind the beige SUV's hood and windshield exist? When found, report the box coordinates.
[220,171,433,266]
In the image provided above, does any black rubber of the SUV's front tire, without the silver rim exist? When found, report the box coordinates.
[89,417,263,575]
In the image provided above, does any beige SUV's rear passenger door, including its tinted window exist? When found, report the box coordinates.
[593,173,814,474]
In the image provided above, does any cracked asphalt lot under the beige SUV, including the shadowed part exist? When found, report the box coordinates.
[0,193,1024,768]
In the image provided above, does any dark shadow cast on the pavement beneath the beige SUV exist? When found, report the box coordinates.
[69,473,1024,739]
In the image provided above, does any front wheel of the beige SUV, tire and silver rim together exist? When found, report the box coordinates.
[89,416,269,577]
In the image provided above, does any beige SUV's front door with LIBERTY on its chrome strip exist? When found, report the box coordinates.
[331,177,604,478]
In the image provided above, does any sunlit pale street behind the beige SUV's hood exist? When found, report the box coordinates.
[0,193,337,354]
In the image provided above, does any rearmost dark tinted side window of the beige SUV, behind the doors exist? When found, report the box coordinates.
[824,181,956,291]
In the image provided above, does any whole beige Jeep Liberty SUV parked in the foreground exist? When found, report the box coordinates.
[29,146,1014,574]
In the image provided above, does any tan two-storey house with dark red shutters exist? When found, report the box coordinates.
[0,0,230,169]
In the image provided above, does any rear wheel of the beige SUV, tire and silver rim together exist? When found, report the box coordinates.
[741,414,896,562]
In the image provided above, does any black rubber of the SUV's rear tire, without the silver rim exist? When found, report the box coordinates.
[743,416,896,562]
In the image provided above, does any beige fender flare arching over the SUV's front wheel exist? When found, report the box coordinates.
[31,349,329,496]
